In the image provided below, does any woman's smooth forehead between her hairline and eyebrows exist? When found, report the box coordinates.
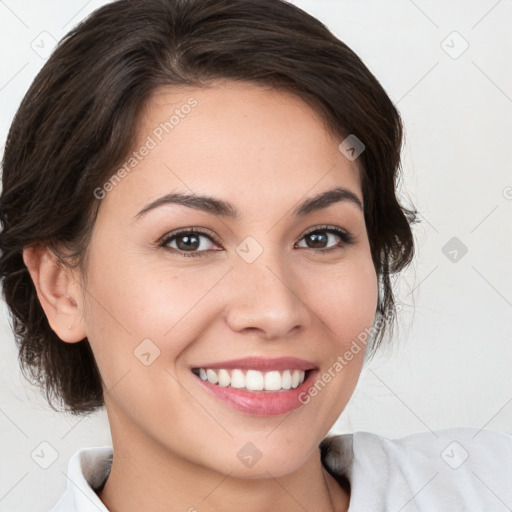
[101,81,362,220]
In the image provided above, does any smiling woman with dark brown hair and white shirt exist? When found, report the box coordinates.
[0,0,512,512]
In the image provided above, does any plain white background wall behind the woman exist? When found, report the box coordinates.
[0,0,512,512]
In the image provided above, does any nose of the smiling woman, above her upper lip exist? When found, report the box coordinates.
[226,251,310,340]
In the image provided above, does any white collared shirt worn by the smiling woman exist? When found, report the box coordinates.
[50,427,512,512]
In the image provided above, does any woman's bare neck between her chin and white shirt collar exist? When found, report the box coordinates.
[98,420,349,512]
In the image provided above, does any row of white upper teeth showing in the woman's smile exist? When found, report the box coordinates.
[194,368,306,391]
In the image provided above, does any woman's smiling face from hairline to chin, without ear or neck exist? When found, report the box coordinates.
[82,82,377,478]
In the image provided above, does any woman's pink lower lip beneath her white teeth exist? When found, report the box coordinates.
[194,370,318,416]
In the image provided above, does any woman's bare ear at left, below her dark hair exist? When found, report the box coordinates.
[23,245,86,343]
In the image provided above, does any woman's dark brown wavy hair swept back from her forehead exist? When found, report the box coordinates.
[0,0,416,414]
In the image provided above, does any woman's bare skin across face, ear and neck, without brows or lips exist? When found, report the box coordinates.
[24,81,378,512]
